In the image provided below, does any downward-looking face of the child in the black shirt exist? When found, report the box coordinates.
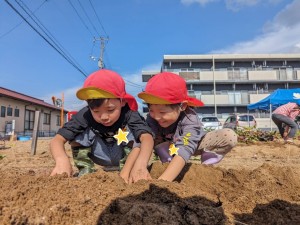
[90,98,126,127]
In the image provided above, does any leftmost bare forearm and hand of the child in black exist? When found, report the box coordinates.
[50,134,72,176]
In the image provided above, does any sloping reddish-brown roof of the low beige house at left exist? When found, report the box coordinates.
[0,87,68,112]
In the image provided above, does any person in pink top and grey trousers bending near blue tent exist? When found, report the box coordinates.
[272,102,300,144]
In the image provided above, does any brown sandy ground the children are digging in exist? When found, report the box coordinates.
[0,140,300,225]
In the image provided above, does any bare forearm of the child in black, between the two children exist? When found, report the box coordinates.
[128,133,154,183]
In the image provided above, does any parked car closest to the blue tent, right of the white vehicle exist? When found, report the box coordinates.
[223,114,257,130]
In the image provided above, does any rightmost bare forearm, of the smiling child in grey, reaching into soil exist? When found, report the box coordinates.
[158,155,185,181]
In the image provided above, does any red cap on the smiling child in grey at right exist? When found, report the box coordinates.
[138,72,204,107]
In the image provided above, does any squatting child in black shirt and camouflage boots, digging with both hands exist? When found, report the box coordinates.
[50,69,153,182]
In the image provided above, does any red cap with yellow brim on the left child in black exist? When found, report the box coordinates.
[76,69,138,111]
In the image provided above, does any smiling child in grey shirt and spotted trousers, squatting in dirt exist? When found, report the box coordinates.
[138,72,237,181]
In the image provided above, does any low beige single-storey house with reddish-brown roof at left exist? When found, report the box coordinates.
[0,87,68,137]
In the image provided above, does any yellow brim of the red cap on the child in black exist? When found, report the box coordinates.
[76,87,118,100]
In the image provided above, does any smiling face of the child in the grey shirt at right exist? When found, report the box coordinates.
[149,104,182,128]
